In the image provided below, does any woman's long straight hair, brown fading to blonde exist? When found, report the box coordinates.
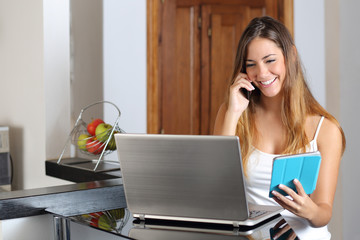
[230,16,346,175]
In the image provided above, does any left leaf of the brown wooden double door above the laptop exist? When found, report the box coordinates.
[161,3,200,134]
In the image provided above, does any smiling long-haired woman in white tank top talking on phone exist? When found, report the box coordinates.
[214,17,345,239]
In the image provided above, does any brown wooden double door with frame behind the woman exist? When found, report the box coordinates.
[147,0,292,134]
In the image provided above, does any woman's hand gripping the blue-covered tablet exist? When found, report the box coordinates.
[272,179,317,220]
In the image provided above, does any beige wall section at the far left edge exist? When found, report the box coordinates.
[0,0,45,188]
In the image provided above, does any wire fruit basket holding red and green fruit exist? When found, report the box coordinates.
[57,101,125,171]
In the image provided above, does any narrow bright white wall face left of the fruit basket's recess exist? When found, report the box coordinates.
[43,0,71,165]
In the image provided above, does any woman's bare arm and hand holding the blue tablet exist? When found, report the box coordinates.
[274,119,342,227]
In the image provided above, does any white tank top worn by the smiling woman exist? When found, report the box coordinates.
[245,116,331,239]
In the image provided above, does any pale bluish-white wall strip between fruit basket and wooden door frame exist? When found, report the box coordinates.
[104,0,146,133]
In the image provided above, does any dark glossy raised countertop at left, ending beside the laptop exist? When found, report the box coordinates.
[0,178,126,220]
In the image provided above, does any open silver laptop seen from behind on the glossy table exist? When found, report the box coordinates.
[115,134,283,227]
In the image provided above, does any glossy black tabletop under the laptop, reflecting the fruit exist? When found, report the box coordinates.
[68,208,291,240]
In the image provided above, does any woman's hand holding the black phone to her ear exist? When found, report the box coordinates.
[228,73,255,117]
